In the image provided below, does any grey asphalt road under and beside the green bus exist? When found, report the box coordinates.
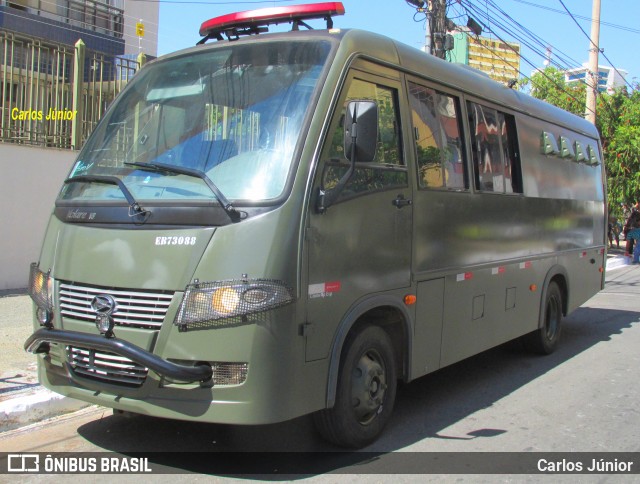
[0,266,640,482]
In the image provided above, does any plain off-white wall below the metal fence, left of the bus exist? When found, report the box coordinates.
[0,143,77,291]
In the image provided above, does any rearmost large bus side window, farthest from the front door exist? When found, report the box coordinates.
[467,102,522,193]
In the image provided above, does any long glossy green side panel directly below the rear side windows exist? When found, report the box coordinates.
[413,190,604,274]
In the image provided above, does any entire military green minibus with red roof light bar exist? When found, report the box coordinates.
[25,2,607,447]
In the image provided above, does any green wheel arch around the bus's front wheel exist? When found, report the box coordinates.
[326,295,413,408]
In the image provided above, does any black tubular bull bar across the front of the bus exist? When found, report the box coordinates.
[24,328,213,382]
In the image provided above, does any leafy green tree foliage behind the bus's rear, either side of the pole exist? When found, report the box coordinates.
[527,67,640,216]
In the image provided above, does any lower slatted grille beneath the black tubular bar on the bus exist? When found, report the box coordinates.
[67,346,149,387]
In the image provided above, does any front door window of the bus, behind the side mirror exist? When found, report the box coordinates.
[322,79,408,200]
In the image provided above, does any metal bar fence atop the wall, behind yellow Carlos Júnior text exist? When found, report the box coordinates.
[0,32,144,149]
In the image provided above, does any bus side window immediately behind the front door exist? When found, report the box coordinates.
[409,82,469,189]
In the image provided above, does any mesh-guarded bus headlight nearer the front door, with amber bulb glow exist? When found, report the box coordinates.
[174,279,293,329]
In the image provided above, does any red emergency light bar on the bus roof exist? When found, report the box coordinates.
[198,2,344,44]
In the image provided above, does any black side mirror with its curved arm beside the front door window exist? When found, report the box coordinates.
[316,101,378,213]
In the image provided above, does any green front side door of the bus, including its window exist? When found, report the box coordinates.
[304,75,413,361]
